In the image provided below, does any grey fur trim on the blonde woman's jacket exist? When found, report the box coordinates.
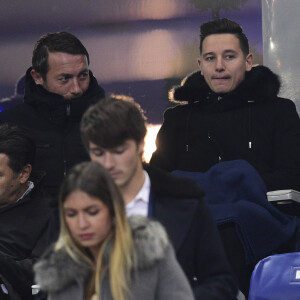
[34,216,170,293]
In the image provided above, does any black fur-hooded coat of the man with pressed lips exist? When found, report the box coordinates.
[151,66,300,190]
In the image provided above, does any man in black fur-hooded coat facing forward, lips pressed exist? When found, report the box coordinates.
[150,19,300,191]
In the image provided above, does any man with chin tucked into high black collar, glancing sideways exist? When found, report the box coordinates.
[0,32,104,196]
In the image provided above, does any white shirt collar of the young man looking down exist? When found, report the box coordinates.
[126,170,151,217]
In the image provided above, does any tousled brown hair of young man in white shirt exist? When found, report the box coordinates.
[80,95,147,150]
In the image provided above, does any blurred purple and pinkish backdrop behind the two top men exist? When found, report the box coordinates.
[0,0,263,124]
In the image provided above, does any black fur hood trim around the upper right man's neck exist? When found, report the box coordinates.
[169,66,280,105]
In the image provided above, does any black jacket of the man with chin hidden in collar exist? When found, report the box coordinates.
[0,68,104,196]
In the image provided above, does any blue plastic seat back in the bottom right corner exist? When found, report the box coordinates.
[248,252,300,300]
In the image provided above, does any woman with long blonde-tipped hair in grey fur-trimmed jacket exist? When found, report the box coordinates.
[34,162,194,300]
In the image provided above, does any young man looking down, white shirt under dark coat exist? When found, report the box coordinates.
[81,98,237,300]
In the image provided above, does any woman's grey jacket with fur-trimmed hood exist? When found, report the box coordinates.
[34,216,194,300]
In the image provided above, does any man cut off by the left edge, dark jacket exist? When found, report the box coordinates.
[0,124,52,300]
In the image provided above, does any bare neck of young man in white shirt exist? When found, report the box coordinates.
[120,164,145,205]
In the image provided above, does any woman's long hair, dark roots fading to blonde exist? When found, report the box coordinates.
[55,162,135,300]
